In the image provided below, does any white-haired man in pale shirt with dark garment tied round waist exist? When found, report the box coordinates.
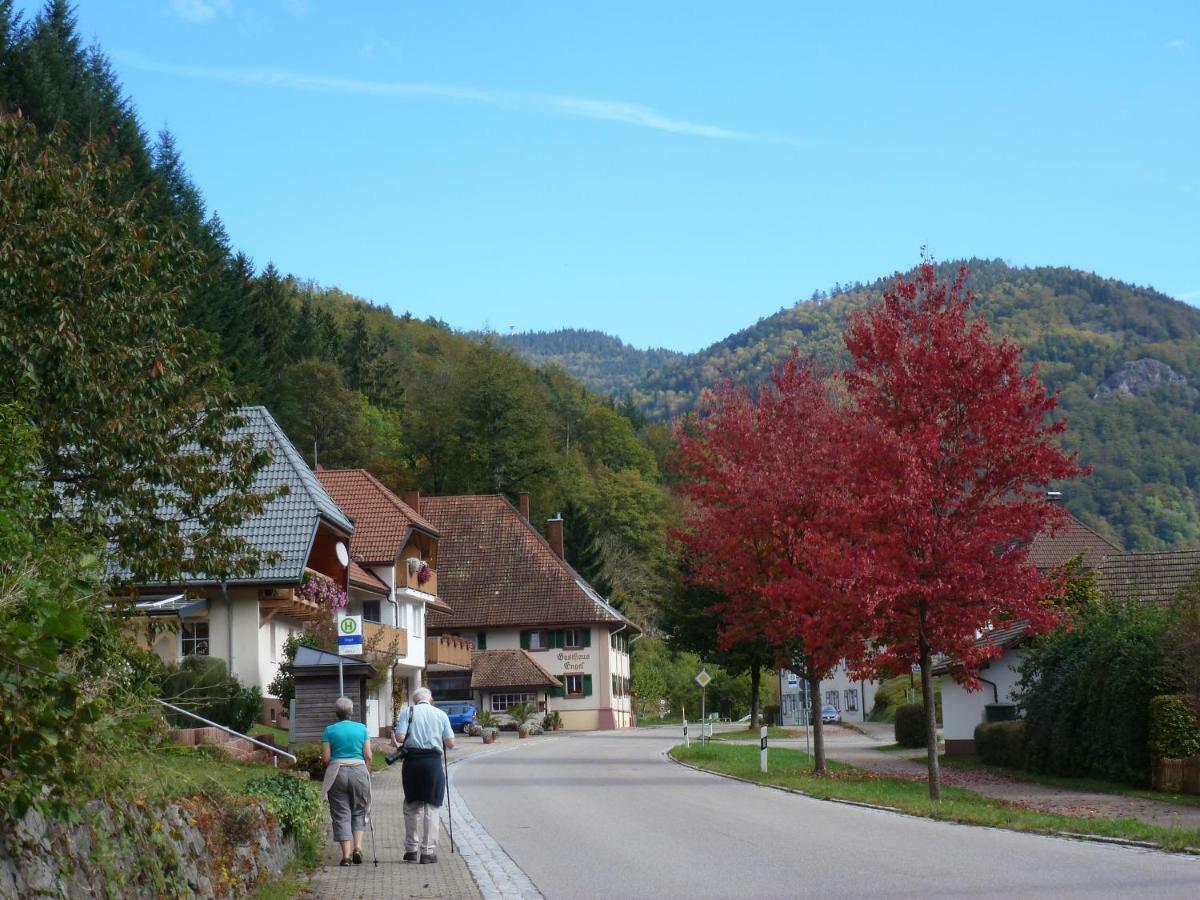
[392,688,455,863]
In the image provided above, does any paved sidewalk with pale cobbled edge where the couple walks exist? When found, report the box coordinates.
[302,733,544,900]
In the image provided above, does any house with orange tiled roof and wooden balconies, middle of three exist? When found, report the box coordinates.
[317,467,470,734]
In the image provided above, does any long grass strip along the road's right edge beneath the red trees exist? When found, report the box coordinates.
[671,743,1200,851]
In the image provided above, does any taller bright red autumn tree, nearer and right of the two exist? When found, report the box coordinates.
[845,260,1080,799]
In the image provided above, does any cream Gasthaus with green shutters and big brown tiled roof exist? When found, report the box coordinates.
[418,494,638,730]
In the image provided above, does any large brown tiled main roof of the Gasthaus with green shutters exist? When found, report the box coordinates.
[421,494,637,631]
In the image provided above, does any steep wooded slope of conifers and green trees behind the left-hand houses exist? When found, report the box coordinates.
[0,0,671,618]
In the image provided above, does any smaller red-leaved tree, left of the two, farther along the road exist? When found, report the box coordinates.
[674,356,872,772]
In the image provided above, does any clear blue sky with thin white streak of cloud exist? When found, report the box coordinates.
[25,0,1200,350]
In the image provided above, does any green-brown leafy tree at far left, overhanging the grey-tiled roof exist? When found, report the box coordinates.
[0,118,268,582]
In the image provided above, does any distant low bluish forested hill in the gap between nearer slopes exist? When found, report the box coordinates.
[469,328,683,396]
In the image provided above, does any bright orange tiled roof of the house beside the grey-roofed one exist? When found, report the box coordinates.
[317,469,438,563]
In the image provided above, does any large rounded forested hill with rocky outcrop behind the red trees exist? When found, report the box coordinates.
[501,259,1200,550]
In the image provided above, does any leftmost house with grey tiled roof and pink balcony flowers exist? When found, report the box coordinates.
[138,407,354,724]
